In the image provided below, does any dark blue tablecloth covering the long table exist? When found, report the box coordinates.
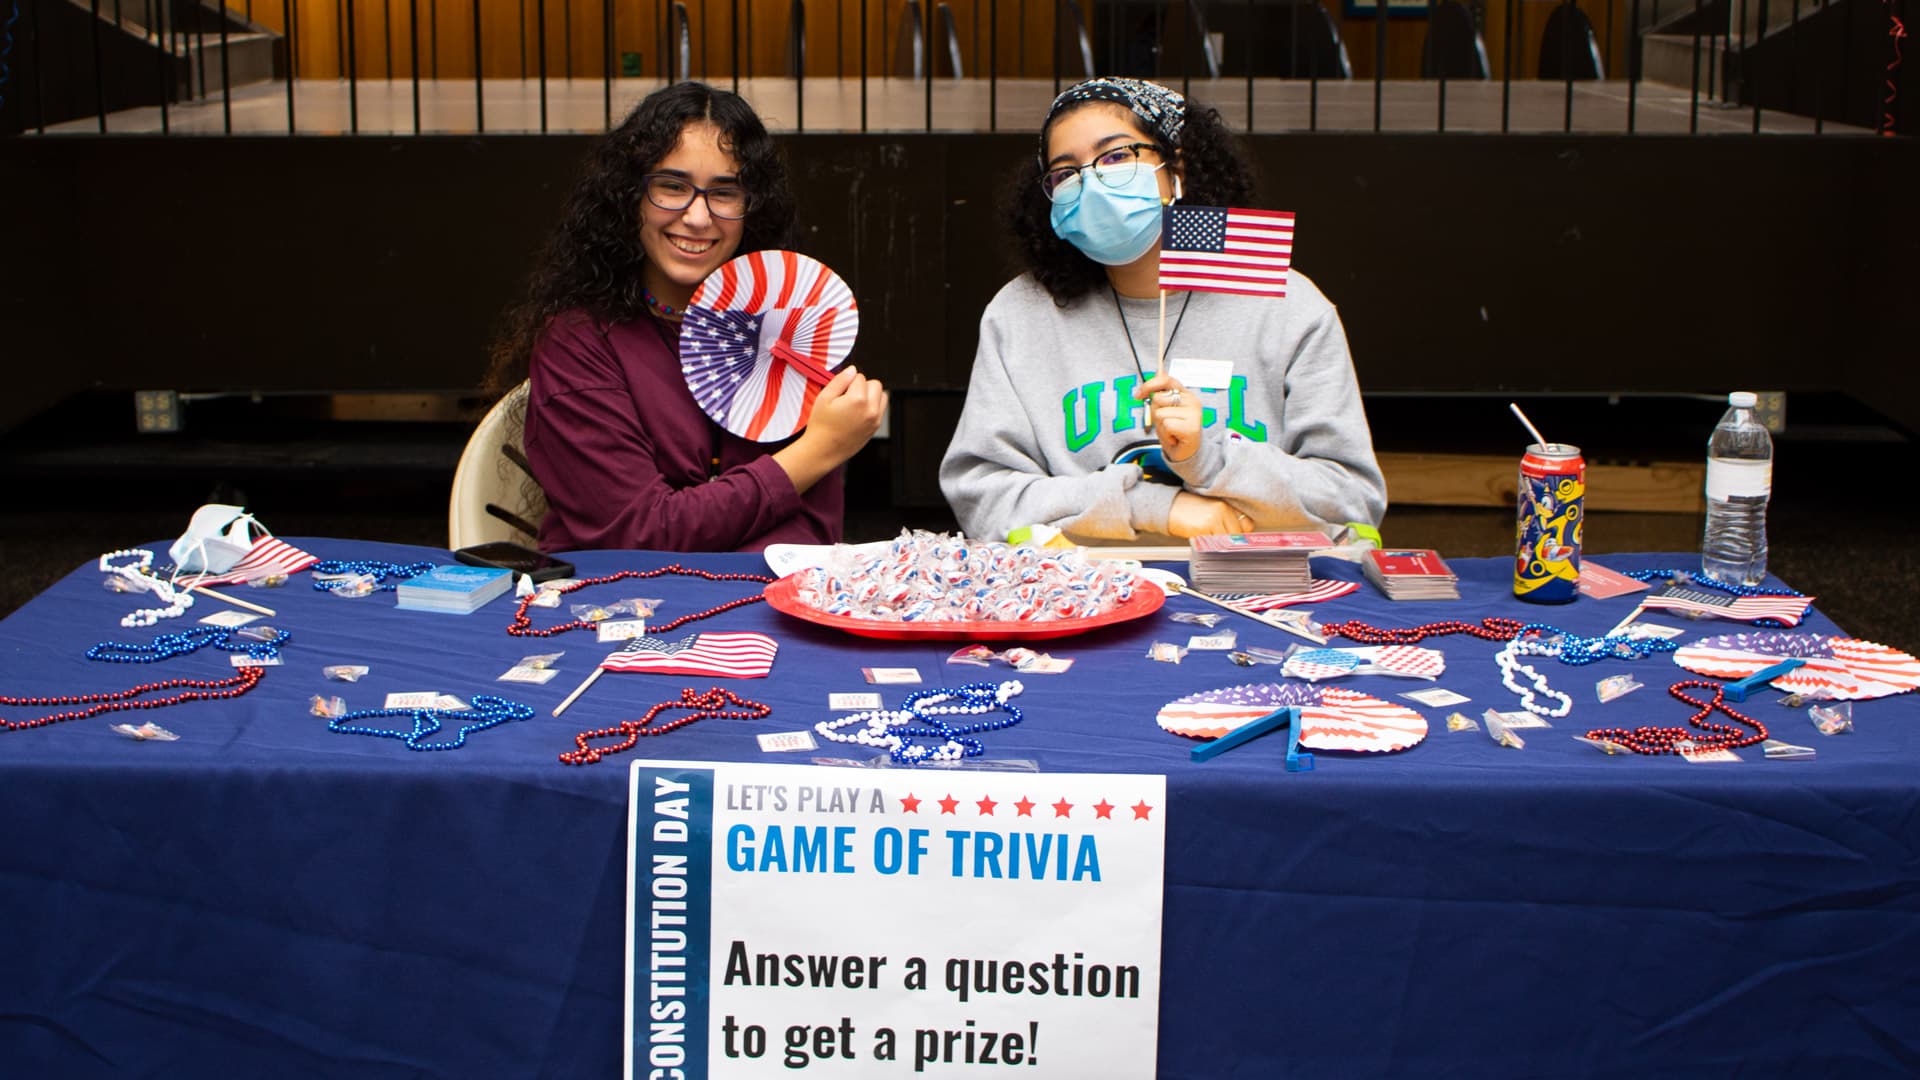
[0,540,1920,1078]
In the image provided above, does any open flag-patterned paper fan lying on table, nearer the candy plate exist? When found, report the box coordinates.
[1154,682,1427,753]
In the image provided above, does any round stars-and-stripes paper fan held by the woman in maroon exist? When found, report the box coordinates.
[680,252,860,442]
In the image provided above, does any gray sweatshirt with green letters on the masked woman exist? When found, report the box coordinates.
[941,271,1386,544]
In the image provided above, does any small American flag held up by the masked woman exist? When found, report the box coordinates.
[1160,206,1294,296]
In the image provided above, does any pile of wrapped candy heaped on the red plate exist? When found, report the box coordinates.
[799,530,1152,623]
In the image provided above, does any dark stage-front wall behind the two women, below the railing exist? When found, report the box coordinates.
[0,135,1920,430]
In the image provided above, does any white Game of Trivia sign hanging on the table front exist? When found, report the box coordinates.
[626,761,1165,1080]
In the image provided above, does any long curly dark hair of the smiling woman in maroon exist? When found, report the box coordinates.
[484,83,793,396]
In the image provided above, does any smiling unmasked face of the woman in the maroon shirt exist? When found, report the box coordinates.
[639,121,747,307]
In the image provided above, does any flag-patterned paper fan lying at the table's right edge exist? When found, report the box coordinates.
[1674,630,1920,701]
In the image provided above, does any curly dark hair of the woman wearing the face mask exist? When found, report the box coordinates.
[1002,98,1254,307]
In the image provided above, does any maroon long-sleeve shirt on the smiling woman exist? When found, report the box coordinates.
[526,311,845,552]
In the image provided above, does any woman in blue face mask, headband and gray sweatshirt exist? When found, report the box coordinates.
[941,79,1386,544]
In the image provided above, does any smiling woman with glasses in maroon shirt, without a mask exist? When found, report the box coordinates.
[488,83,887,552]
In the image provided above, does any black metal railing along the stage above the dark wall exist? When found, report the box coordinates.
[0,0,1914,135]
